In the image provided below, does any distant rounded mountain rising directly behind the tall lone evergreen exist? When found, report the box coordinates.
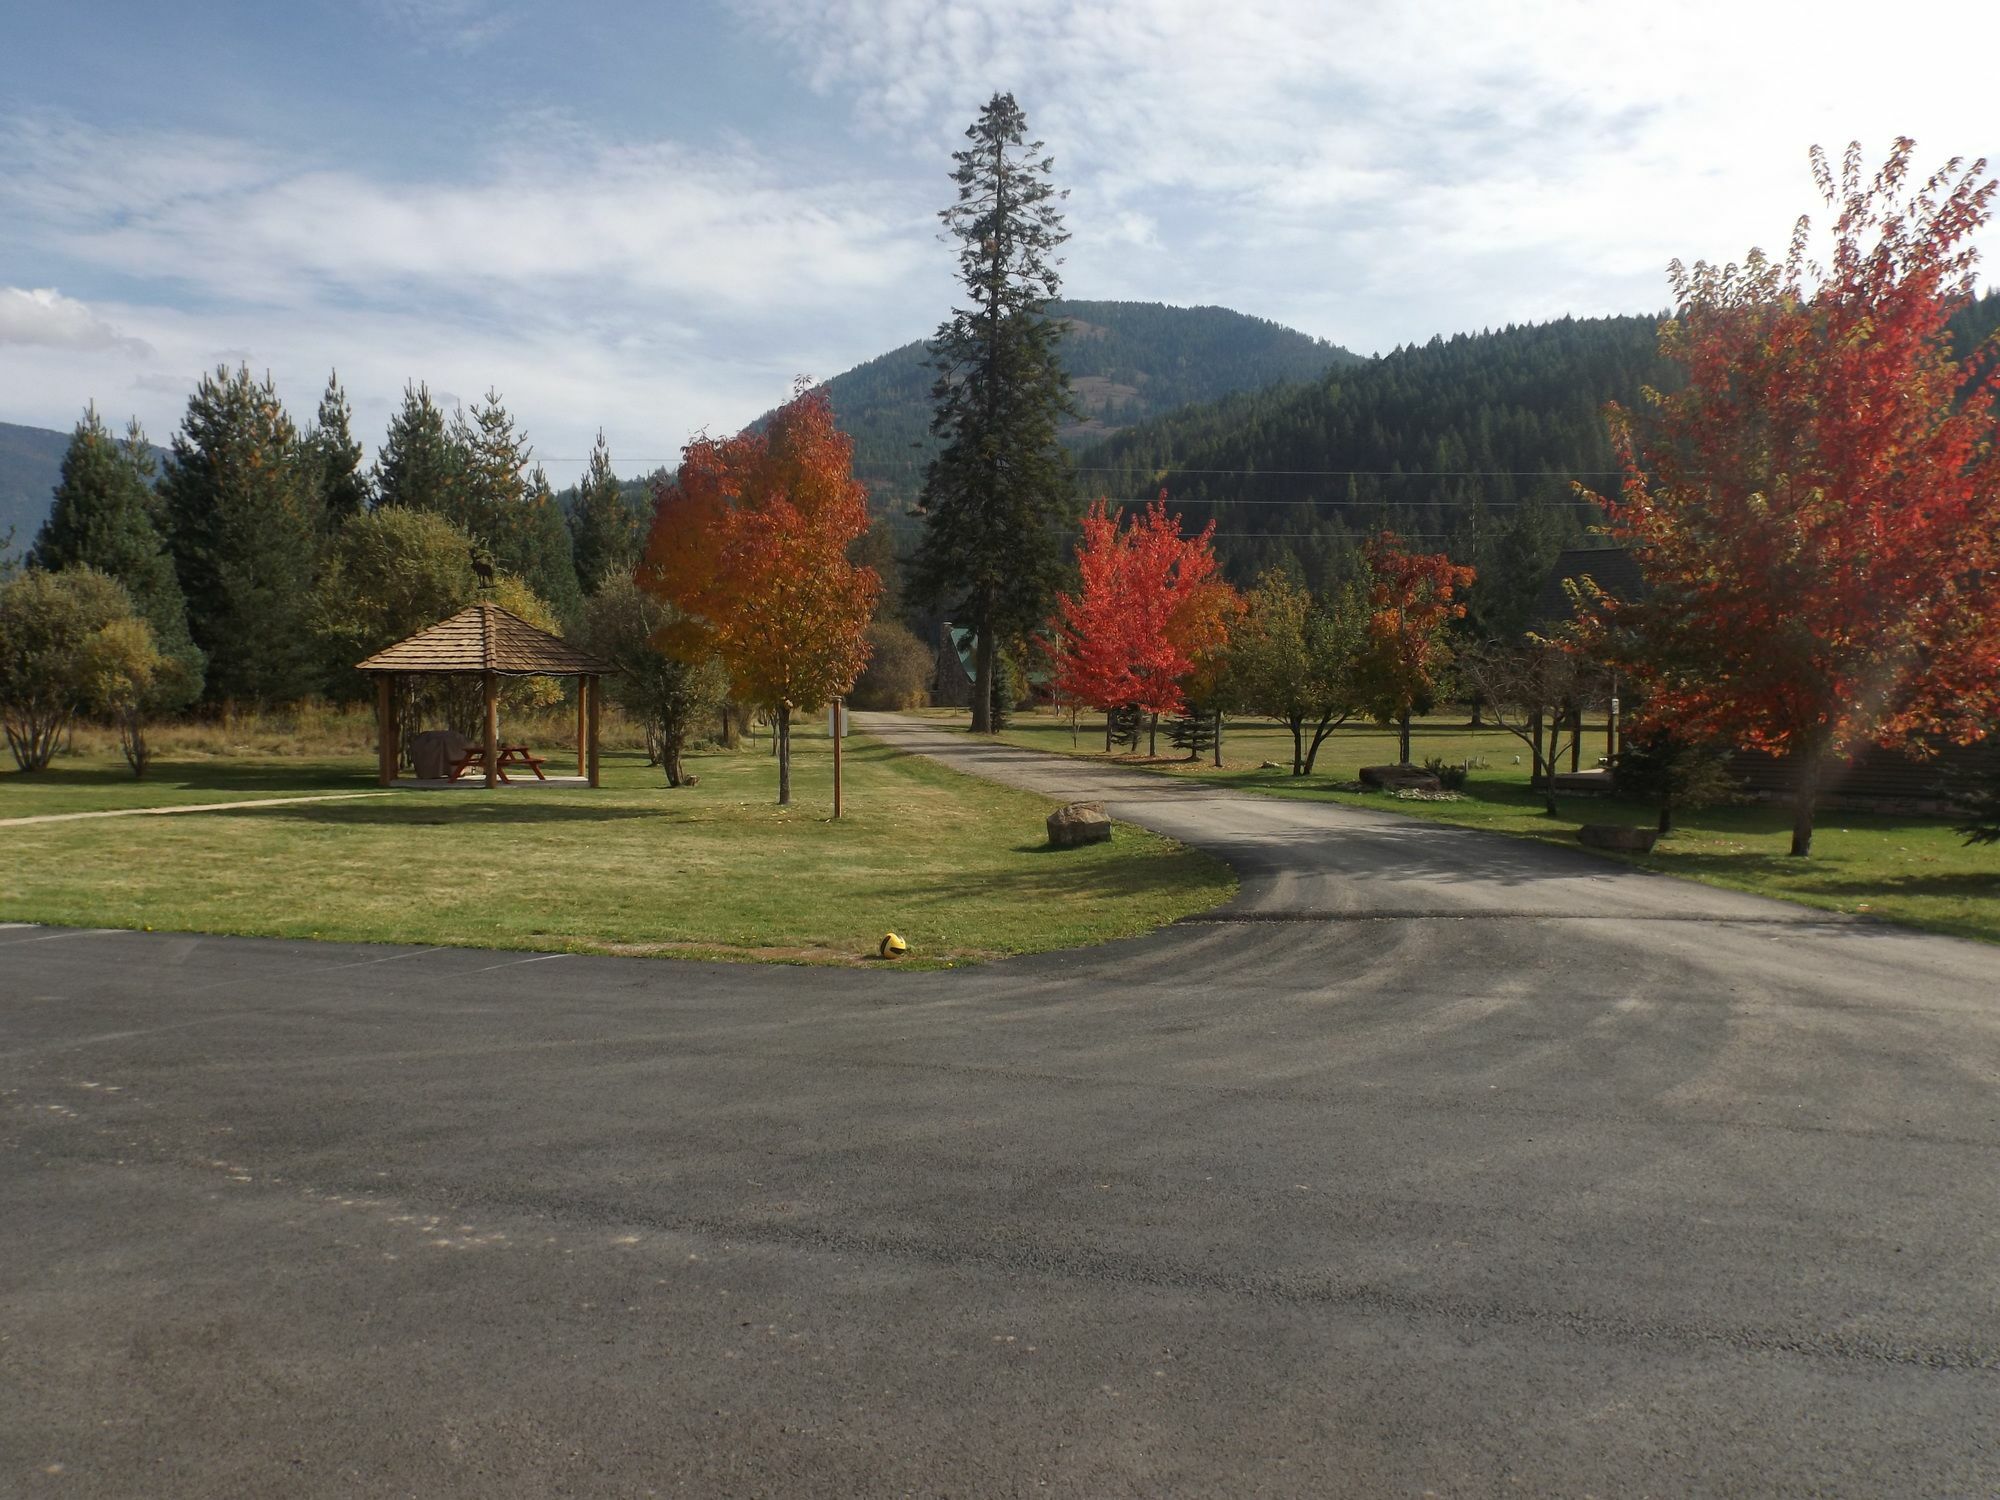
[826,302,1362,514]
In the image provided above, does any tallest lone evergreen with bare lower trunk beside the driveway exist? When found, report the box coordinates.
[914,94,1074,732]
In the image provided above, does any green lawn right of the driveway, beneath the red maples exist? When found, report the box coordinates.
[932,710,2000,942]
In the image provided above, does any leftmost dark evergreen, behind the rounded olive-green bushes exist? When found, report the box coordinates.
[28,406,204,708]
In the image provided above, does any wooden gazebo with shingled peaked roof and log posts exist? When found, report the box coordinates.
[356,604,618,786]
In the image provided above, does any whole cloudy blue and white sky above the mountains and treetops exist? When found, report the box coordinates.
[0,0,2000,484]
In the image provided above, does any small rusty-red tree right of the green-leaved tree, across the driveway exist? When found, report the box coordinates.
[1360,532,1478,764]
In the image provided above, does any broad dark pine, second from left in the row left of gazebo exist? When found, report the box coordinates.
[160,366,320,704]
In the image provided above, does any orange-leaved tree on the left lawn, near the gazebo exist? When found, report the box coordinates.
[638,394,882,804]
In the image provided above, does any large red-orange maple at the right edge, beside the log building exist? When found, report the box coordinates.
[1580,140,2000,856]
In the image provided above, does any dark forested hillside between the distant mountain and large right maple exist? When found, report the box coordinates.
[1080,318,1666,628]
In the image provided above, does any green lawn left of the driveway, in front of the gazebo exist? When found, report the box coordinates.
[0,736,1236,964]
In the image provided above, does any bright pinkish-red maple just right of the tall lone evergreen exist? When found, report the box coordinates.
[1052,492,1242,752]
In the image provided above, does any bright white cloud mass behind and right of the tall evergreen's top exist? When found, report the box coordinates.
[734,0,2000,348]
